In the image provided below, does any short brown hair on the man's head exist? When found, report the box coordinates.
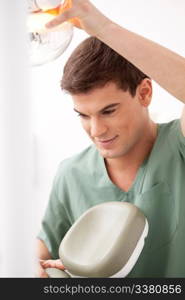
[61,37,149,96]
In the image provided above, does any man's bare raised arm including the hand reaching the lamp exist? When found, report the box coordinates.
[46,0,185,103]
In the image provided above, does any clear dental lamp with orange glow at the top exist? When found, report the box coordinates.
[27,0,73,66]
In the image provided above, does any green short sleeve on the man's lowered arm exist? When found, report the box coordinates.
[37,163,71,259]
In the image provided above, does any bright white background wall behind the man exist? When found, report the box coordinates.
[32,0,185,223]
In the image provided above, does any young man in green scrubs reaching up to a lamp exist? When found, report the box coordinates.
[38,0,185,277]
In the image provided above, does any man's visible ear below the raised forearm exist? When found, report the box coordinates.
[136,78,152,107]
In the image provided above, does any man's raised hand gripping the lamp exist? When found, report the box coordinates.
[46,0,111,36]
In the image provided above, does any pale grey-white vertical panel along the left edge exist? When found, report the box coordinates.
[0,0,37,277]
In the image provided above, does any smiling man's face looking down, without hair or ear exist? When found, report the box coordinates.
[72,82,151,158]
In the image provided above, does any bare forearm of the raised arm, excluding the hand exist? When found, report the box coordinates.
[97,22,185,103]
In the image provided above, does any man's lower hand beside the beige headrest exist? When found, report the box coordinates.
[36,259,65,278]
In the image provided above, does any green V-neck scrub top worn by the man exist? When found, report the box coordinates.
[38,120,185,277]
